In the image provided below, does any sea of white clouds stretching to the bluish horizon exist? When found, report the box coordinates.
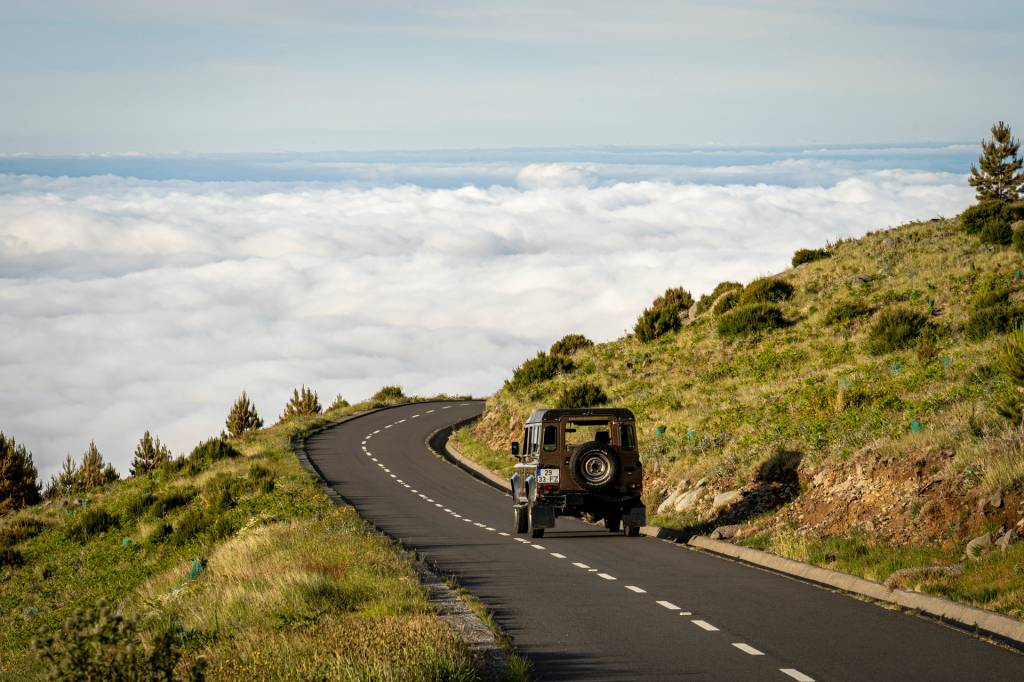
[0,147,973,476]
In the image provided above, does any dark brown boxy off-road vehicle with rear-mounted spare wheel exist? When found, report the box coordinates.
[512,408,647,538]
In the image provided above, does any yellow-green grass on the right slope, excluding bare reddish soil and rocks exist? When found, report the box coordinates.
[454,218,1024,612]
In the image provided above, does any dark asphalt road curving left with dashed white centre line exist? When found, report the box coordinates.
[306,401,1024,682]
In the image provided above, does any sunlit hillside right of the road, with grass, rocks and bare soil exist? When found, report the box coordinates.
[456,218,1024,616]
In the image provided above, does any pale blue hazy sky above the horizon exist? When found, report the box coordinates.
[0,0,1024,154]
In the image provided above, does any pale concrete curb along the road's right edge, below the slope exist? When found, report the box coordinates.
[435,425,1024,648]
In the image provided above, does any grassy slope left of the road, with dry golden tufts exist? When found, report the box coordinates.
[0,395,507,680]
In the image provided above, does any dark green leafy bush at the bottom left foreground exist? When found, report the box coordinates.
[32,600,206,682]
